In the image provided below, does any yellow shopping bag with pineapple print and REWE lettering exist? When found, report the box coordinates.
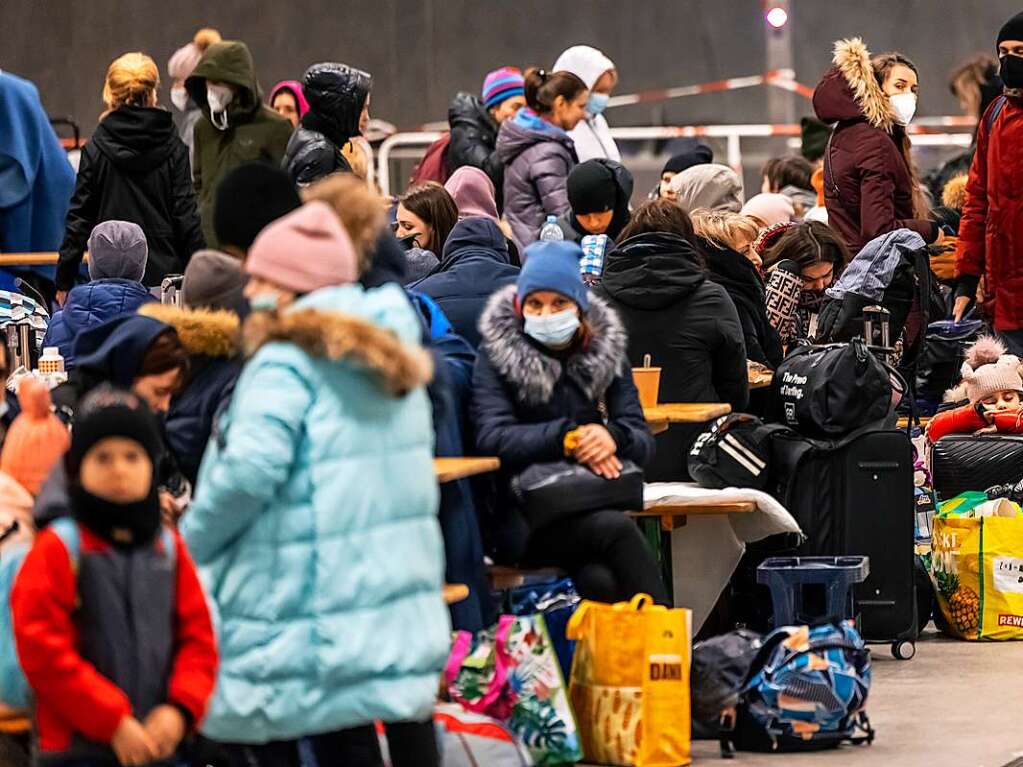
[930,498,1023,639]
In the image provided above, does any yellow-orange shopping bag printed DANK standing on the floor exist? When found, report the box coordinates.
[567,594,692,767]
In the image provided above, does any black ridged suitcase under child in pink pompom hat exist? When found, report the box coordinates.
[931,434,1023,501]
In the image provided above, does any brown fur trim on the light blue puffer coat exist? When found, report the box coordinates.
[242,309,434,397]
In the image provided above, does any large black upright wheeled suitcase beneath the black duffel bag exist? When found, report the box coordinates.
[771,430,920,659]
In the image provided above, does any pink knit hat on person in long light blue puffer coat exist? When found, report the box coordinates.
[246,200,359,294]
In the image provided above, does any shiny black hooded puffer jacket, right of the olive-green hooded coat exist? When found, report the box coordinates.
[281,62,372,184]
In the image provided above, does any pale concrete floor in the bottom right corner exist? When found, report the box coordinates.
[693,625,1023,767]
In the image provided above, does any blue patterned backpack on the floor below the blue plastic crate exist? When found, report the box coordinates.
[721,622,874,758]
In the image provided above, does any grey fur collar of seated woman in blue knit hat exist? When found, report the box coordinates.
[480,285,628,406]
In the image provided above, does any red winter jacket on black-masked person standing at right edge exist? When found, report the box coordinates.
[955,97,1023,330]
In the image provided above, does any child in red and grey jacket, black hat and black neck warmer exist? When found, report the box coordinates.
[11,387,217,767]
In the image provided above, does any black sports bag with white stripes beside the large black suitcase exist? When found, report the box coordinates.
[688,413,792,490]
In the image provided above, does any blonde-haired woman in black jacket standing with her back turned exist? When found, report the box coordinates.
[56,53,205,305]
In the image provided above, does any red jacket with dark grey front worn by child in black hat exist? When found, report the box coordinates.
[11,526,217,761]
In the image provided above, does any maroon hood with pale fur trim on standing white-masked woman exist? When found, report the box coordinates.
[813,37,895,133]
